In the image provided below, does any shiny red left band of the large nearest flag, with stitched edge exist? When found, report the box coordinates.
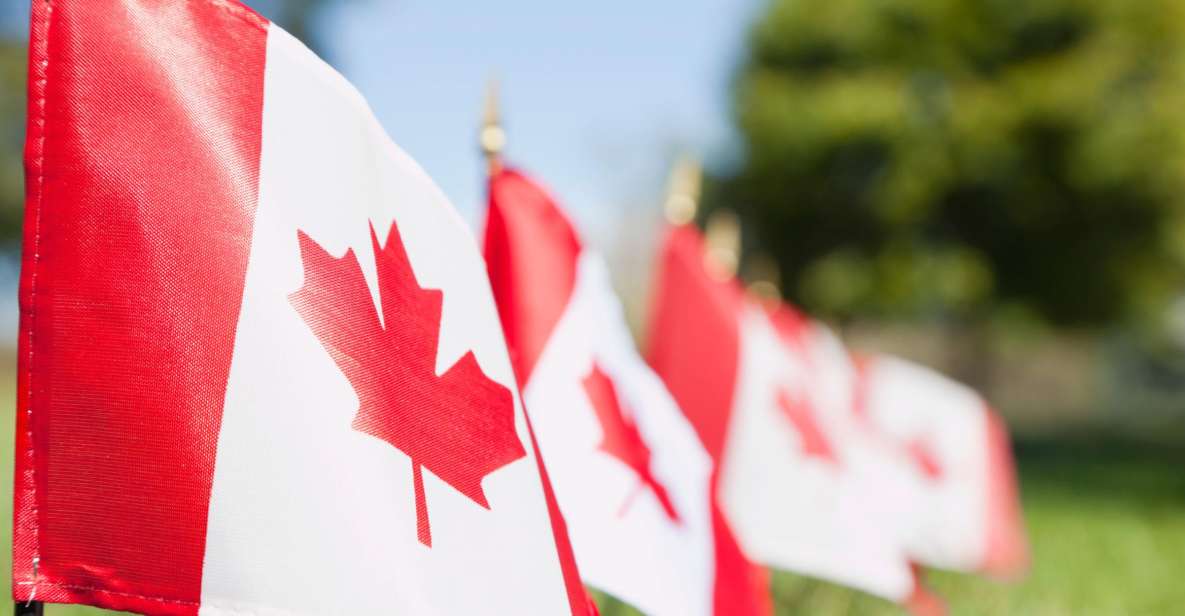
[13,0,268,614]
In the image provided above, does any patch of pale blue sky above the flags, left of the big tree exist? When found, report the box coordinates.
[320,0,761,236]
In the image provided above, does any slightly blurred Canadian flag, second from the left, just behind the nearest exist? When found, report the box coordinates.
[485,169,770,616]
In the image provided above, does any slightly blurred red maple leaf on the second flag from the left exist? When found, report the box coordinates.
[582,364,679,521]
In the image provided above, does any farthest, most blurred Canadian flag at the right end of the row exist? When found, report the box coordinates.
[853,357,1029,577]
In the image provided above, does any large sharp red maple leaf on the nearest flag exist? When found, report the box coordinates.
[289,223,526,546]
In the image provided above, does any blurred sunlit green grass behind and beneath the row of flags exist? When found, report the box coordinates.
[0,355,1185,616]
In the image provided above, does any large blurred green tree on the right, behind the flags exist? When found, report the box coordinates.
[707,0,1185,326]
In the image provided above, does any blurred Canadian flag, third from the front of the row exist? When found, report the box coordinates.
[648,226,940,604]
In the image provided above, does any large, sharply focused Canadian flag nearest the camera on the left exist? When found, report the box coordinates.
[13,0,588,615]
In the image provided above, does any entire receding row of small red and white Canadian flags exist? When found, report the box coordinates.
[13,0,1027,616]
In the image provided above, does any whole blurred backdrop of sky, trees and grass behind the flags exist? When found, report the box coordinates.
[0,0,1185,616]
